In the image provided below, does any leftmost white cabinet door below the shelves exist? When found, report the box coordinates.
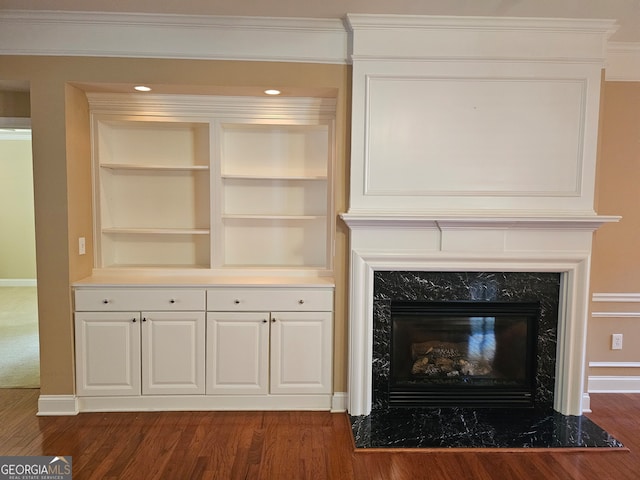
[75,312,140,396]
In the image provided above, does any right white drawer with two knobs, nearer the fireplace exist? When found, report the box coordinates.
[207,288,333,312]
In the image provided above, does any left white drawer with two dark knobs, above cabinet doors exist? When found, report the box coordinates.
[75,288,205,312]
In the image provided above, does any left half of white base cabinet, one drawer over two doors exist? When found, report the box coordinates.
[75,289,205,396]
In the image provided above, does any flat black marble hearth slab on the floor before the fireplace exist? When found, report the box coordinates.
[351,408,623,449]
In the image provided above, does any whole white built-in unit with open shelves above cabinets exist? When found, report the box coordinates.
[74,94,336,411]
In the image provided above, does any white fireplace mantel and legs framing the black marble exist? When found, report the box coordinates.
[342,213,617,416]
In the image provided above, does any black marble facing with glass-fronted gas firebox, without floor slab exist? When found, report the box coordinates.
[372,271,562,410]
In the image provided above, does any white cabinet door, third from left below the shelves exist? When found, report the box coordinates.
[207,312,269,395]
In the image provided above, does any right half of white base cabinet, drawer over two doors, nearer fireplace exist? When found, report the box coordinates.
[207,288,333,395]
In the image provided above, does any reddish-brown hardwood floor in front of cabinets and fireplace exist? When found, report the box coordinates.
[0,389,640,480]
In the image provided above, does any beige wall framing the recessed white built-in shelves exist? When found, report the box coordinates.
[0,56,350,395]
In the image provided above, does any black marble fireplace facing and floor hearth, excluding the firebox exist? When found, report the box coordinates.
[350,271,622,448]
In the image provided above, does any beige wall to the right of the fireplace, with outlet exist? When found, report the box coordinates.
[587,82,640,376]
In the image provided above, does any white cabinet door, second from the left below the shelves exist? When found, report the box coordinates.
[142,312,205,395]
